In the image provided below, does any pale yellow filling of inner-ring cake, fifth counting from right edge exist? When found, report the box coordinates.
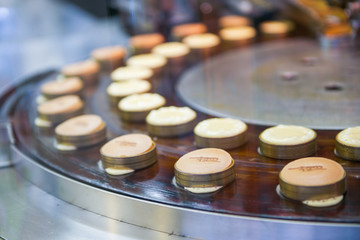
[119,93,166,112]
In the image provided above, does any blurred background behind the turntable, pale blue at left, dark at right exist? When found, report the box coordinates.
[0,0,360,86]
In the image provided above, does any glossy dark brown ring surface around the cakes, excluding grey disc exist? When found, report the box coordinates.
[4,63,360,223]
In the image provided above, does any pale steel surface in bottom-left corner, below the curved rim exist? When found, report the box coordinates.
[0,168,184,240]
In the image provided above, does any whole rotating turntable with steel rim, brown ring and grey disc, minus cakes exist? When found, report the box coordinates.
[1,37,360,239]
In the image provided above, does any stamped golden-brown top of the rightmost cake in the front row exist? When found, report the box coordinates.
[280,157,345,186]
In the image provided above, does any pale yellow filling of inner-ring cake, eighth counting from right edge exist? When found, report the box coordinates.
[126,53,167,69]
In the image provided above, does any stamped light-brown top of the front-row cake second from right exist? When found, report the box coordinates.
[175,148,233,174]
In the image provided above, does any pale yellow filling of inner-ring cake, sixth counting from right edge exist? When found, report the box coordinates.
[106,79,151,97]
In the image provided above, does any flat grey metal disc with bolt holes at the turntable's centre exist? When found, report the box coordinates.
[177,40,360,129]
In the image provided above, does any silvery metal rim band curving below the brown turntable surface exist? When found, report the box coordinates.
[11,145,360,239]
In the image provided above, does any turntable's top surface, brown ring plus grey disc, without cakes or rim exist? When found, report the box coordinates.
[6,40,360,223]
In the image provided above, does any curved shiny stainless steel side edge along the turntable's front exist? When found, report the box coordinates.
[11,145,360,240]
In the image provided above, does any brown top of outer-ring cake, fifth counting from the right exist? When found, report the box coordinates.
[37,95,83,115]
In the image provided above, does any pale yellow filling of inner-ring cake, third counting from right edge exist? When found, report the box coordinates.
[194,118,247,138]
